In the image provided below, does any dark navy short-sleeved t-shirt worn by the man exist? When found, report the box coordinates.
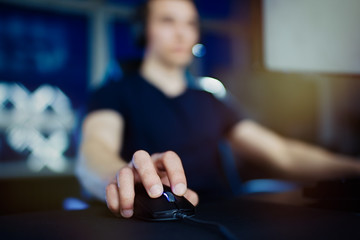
[88,74,242,199]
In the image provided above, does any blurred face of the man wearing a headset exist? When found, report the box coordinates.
[146,0,199,67]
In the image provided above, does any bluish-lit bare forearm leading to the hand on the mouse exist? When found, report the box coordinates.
[76,140,127,201]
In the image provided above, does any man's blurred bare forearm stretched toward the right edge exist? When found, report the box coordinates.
[230,121,360,182]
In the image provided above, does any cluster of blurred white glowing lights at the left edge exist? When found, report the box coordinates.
[0,83,75,172]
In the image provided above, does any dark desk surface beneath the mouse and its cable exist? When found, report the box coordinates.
[0,193,360,240]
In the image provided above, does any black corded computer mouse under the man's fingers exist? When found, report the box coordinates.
[134,183,195,221]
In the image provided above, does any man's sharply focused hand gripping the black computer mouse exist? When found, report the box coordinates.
[106,150,199,218]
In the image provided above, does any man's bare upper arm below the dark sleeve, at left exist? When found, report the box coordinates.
[82,110,124,153]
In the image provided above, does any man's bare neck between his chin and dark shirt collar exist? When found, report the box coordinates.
[140,57,186,97]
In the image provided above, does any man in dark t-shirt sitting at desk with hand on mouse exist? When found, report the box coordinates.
[77,0,360,218]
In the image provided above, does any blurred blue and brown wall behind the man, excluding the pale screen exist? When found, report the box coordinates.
[0,0,360,177]
